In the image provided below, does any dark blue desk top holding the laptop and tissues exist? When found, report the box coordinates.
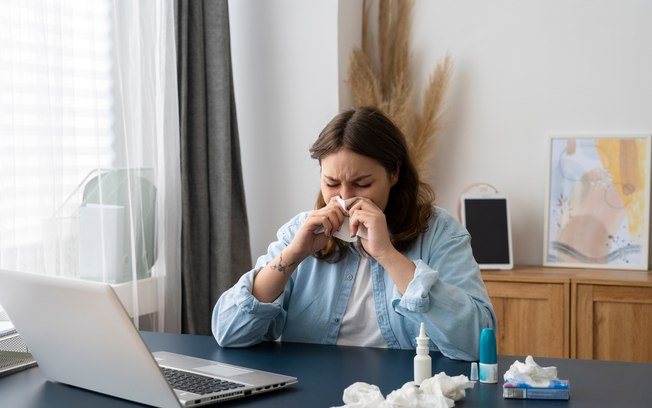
[0,332,652,408]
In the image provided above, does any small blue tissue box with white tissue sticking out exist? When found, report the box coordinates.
[503,356,570,400]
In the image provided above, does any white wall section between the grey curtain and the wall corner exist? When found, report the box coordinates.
[229,0,339,260]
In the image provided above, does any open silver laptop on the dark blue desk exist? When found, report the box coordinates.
[0,269,297,407]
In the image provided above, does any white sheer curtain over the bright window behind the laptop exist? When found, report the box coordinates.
[0,0,181,331]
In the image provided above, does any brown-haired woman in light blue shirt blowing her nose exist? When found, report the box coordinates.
[212,107,495,361]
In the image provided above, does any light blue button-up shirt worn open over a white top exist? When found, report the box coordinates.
[212,207,496,361]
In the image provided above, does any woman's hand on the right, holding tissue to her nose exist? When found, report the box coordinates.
[348,197,395,258]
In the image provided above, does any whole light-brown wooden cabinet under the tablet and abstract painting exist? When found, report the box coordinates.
[482,267,652,362]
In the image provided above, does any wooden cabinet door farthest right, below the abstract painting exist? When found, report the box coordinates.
[573,284,652,362]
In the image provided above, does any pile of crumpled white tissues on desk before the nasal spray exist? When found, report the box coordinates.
[338,372,475,408]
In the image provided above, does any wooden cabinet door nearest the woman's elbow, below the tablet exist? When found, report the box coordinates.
[485,281,570,358]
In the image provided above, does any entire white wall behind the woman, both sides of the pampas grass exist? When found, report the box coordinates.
[229,0,652,264]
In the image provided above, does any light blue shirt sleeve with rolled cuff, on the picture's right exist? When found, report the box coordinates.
[391,211,496,361]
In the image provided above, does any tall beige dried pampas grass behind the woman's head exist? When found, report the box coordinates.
[348,0,453,180]
